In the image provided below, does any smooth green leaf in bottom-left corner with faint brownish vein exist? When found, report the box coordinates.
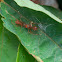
[0,15,19,62]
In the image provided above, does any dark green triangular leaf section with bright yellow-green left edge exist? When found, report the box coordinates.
[16,44,37,62]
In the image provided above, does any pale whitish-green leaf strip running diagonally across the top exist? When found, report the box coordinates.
[14,0,62,23]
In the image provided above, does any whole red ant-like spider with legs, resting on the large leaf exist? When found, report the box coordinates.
[8,11,38,35]
